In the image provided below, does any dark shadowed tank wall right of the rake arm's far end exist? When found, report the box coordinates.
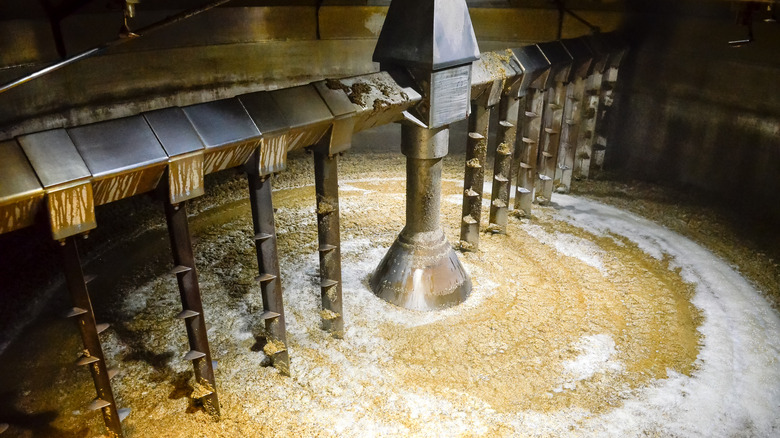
[606,1,780,221]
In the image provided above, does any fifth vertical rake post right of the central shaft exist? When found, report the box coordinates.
[553,78,585,193]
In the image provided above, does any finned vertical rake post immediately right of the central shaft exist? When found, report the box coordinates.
[460,102,490,251]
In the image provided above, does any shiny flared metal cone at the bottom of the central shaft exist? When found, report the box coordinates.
[370,228,471,310]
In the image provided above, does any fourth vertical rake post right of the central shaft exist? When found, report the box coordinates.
[536,83,565,205]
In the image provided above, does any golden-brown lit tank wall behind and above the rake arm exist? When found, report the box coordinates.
[0,0,623,139]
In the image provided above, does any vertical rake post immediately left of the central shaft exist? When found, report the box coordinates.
[313,145,344,338]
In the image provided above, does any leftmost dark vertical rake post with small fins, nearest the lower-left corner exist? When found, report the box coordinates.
[61,236,122,438]
